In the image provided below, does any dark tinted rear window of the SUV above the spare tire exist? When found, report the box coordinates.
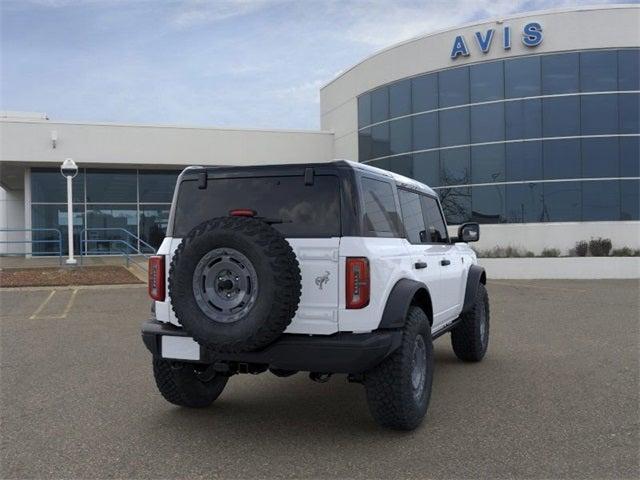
[173,175,340,238]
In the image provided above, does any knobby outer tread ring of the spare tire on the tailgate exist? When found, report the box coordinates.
[169,217,302,352]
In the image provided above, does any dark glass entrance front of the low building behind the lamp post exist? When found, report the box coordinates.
[30,168,180,255]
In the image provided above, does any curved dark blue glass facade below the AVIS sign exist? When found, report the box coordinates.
[357,48,640,224]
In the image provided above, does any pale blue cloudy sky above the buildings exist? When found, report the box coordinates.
[0,0,632,129]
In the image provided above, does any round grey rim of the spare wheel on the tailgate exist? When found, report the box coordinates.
[193,248,258,323]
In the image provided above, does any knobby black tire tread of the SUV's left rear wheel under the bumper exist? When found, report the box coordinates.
[153,358,227,408]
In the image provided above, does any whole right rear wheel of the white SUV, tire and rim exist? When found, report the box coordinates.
[364,307,433,430]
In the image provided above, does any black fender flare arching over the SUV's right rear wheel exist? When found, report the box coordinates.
[378,278,433,329]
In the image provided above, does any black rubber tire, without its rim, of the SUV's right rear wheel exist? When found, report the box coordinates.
[364,307,433,430]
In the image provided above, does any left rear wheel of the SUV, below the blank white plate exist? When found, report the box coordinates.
[153,358,228,408]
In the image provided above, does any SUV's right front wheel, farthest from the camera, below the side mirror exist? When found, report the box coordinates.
[451,284,489,362]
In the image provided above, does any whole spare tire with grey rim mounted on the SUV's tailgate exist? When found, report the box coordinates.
[169,217,301,352]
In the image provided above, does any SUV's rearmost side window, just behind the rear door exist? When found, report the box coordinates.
[361,177,401,237]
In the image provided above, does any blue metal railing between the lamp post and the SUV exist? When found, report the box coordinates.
[80,227,156,270]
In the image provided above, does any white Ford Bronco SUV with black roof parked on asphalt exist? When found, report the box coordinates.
[142,160,489,430]
